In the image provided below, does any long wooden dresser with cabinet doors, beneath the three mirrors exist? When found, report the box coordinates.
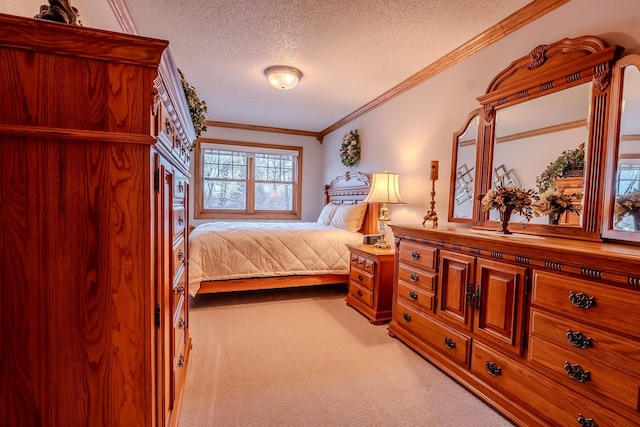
[389,225,640,427]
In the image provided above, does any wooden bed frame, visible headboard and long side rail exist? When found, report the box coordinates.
[198,172,379,294]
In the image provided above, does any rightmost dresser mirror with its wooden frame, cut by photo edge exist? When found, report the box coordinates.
[603,54,640,242]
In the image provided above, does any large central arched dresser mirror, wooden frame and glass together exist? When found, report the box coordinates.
[474,36,622,240]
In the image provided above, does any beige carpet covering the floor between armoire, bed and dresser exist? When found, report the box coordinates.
[179,286,512,427]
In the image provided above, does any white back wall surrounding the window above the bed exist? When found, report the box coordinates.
[189,126,322,226]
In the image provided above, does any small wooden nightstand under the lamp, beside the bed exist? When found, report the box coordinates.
[347,244,395,325]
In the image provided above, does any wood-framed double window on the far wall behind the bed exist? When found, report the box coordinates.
[195,140,302,219]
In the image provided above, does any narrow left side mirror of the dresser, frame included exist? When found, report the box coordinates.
[449,108,482,223]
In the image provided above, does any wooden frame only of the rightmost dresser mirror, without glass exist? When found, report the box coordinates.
[602,54,640,242]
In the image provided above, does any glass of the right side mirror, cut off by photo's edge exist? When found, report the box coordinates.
[613,66,640,231]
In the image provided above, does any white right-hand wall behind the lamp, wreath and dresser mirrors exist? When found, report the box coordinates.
[323,0,640,231]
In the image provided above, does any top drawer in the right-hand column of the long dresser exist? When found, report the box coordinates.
[531,270,640,338]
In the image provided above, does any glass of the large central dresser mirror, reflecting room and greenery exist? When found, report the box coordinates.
[489,83,591,226]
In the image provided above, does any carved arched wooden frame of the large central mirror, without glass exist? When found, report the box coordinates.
[475,36,622,240]
